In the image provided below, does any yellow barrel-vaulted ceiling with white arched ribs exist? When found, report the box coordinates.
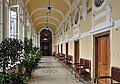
[25,0,74,32]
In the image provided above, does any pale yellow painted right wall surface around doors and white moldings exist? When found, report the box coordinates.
[54,0,120,79]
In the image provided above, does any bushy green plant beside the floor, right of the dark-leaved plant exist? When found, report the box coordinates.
[21,49,42,76]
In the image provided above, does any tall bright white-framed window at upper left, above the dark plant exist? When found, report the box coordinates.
[9,2,20,39]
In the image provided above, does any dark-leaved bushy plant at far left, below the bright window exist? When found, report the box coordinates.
[0,38,23,74]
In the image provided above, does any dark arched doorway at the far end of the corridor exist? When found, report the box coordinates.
[40,29,52,56]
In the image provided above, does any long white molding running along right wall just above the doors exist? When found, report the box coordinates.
[55,19,120,44]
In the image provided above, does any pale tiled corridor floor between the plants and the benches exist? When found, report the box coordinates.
[28,56,86,84]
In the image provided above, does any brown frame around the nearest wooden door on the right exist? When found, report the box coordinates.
[93,31,110,83]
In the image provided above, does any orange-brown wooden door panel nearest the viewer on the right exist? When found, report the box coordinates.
[96,35,110,84]
